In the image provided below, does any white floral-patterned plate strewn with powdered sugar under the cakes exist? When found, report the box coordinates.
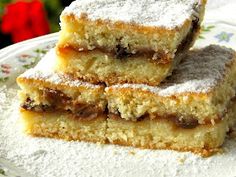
[0,22,236,177]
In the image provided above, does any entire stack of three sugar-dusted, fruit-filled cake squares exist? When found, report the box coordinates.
[17,0,236,155]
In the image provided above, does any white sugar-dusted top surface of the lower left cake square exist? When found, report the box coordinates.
[18,49,103,88]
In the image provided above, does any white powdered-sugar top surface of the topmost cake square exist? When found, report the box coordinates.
[62,0,206,29]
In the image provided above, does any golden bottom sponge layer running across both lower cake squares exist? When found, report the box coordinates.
[20,109,235,156]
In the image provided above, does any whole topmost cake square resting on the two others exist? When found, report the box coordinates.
[57,0,206,86]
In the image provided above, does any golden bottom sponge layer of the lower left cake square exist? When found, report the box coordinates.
[20,109,107,143]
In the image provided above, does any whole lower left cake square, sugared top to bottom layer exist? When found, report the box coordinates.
[17,50,107,143]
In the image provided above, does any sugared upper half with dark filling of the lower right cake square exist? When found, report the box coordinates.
[105,45,236,124]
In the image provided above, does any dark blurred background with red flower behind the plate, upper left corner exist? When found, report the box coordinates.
[0,0,72,48]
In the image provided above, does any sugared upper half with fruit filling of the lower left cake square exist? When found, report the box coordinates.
[17,49,107,113]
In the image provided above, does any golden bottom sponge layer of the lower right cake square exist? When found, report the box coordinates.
[106,115,229,156]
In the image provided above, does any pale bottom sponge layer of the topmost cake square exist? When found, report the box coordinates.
[56,47,180,85]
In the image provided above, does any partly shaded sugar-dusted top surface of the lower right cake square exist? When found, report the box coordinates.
[107,45,236,96]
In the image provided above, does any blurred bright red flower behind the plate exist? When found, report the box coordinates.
[1,0,49,42]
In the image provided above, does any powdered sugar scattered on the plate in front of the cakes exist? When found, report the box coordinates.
[0,88,236,177]
